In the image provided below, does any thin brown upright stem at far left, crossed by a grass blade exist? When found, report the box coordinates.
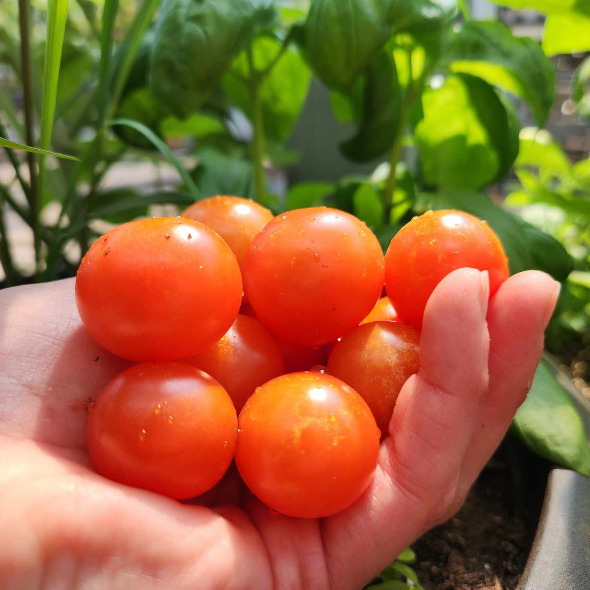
[18,0,41,267]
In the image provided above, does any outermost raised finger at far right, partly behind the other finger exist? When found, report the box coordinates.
[458,271,560,502]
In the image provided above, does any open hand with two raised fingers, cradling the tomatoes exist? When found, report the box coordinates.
[0,269,558,590]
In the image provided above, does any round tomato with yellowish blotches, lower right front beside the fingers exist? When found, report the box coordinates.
[235,372,379,518]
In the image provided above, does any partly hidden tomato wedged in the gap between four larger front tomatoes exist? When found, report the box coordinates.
[187,315,285,412]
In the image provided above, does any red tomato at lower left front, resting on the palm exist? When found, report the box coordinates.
[87,362,237,499]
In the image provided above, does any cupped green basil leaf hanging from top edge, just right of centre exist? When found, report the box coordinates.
[303,0,392,91]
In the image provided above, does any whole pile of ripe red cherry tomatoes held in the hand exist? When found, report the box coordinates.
[76,196,508,518]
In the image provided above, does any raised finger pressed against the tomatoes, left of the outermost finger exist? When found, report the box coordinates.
[323,269,489,588]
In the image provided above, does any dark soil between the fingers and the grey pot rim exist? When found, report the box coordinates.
[412,437,548,590]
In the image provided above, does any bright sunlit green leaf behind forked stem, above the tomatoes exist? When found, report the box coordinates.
[223,37,311,142]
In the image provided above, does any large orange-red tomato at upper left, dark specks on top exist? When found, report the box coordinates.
[76,217,242,361]
